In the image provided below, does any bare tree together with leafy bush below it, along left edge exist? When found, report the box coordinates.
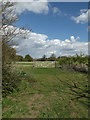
[0,2,19,97]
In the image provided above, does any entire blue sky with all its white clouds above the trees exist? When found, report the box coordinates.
[13,2,90,58]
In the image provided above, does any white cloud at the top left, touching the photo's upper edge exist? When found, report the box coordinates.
[15,0,49,14]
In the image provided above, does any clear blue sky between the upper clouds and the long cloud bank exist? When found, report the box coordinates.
[15,2,88,41]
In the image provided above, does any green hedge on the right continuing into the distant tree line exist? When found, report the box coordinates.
[14,53,89,73]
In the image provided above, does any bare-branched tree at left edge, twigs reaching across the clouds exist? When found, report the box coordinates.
[0,1,29,65]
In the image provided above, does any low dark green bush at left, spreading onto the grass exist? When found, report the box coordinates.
[2,66,36,97]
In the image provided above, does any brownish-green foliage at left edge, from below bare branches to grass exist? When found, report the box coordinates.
[2,40,20,97]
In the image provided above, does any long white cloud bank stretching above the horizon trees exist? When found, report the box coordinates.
[4,27,88,58]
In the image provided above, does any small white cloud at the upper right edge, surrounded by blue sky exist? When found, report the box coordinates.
[71,9,90,24]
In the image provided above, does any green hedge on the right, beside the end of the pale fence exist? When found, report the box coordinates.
[59,54,89,72]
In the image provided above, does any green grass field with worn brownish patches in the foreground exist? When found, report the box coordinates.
[3,67,88,118]
